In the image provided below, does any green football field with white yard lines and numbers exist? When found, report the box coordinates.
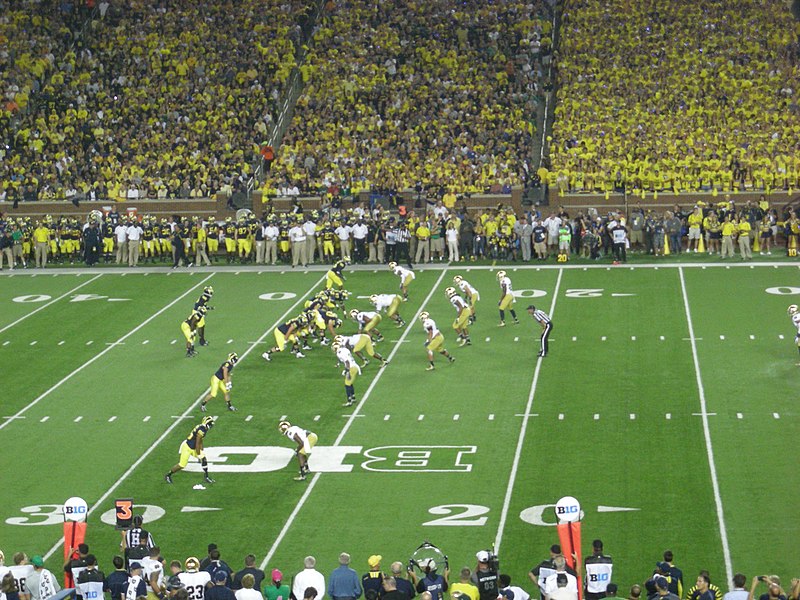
[0,263,800,593]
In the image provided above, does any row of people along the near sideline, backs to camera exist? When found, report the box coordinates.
[0,527,800,600]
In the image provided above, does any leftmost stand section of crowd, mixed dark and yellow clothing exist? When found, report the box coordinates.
[0,0,311,200]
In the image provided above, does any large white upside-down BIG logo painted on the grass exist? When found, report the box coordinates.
[186,446,477,473]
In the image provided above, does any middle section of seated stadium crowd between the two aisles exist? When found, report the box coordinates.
[264,0,551,194]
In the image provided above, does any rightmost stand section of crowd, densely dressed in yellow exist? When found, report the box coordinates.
[548,0,800,192]
